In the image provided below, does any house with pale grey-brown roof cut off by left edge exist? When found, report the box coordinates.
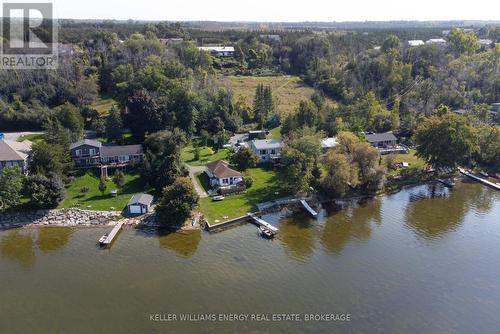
[0,139,32,174]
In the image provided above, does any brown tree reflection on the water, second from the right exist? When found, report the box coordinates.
[320,199,382,255]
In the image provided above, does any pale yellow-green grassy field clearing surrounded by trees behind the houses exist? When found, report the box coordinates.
[221,75,322,114]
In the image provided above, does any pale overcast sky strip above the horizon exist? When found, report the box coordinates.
[13,0,500,22]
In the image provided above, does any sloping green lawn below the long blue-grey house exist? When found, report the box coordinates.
[59,171,144,211]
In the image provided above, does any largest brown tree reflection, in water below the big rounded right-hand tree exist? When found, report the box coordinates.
[405,183,496,240]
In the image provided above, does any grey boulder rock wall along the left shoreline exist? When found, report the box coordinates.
[0,209,121,229]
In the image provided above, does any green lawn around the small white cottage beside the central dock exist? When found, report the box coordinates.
[200,167,288,224]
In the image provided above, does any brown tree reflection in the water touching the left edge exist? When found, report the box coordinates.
[0,231,36,268]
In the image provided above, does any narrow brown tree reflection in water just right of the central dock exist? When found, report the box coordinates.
[278,212,315,262]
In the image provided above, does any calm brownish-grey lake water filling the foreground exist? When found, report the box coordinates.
[0,181,500,333]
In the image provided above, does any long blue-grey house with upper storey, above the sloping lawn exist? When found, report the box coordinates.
[70,139,144,168]
